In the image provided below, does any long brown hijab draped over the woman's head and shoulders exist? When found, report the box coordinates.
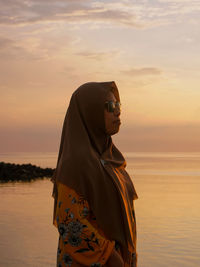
[52,82,138,266]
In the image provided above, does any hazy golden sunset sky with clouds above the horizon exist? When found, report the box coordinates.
[0,0,200,152]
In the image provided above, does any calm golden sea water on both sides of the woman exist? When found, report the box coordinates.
[0,153,200,267]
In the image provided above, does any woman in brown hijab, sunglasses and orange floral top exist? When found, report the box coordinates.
[52,82,138,267]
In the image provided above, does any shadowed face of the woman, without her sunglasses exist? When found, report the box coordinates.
[104,92,121,135]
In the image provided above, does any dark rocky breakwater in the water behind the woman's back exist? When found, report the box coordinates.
[0,162,55,182]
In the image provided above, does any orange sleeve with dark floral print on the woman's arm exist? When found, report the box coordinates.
[57,184,115,267]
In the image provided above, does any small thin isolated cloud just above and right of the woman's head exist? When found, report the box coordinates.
[122,67,162,77]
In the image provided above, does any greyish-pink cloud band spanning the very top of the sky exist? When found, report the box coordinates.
[0,0,200,28]
